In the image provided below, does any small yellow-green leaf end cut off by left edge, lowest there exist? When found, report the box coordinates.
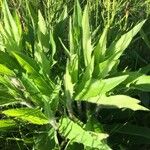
[0,119,16,131]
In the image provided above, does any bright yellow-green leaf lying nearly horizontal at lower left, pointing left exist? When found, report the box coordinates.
[2,108,48,125]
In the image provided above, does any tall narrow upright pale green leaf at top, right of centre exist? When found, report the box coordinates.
[82,6,92,66]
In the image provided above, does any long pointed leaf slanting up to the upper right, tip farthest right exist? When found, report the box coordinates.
[96,20,145,78]
